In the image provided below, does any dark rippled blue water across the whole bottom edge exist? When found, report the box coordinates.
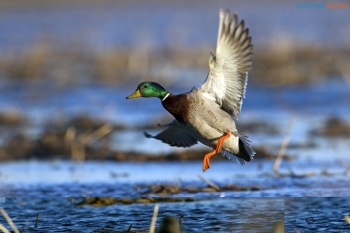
[0,197,350,233]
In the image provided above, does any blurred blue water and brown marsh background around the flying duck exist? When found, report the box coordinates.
[0,0,350,196]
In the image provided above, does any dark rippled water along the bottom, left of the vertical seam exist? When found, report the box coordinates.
[0,197,284,233]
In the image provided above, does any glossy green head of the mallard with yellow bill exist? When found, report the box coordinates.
[126,82,169,99]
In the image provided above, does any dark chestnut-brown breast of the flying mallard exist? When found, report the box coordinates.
[162,93,190,124]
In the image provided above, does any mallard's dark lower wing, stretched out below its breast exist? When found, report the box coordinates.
[144,120,197,147]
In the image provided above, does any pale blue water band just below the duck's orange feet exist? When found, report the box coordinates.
[0,160,350,198]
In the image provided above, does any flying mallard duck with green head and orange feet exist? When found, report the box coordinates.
[126,9,255,172]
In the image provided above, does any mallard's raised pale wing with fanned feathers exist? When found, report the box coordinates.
[199,9,253,118]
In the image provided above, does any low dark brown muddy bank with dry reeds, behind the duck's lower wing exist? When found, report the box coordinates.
[0,132,291,162]
